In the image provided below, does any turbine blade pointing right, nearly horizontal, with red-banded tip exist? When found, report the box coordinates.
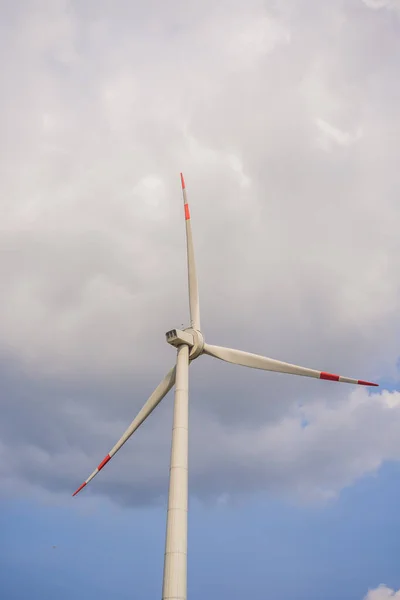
[203,344,378,386]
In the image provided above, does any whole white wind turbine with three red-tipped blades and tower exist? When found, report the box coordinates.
[73,173,378,600]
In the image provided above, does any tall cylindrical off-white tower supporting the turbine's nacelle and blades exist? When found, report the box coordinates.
[162,345,189,600]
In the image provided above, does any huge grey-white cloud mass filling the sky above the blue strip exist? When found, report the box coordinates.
[0,0,400,503]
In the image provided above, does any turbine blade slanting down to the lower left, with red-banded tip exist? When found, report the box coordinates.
[72,366,176,496]
